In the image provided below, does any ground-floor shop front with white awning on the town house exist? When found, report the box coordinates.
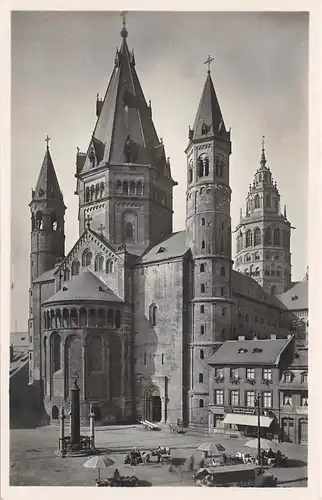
[210,406,278,439]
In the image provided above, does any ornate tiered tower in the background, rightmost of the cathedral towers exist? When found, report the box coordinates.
[235,138,291,294]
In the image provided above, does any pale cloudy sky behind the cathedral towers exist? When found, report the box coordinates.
[11,12,308,331]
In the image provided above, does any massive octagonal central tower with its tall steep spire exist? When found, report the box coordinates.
[76,23,176,254]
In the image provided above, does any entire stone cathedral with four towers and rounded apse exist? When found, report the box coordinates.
[29,19,306,425]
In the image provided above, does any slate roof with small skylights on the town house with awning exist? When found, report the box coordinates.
[208,339,292,365]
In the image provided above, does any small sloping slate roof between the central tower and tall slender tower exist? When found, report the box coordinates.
[141,231,188,264]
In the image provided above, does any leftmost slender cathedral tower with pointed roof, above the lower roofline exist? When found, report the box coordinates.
[29,138,66,284]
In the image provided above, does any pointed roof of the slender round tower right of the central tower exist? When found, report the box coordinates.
[189,69,229,139]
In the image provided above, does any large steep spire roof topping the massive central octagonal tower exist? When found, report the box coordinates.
[82,20,167,175]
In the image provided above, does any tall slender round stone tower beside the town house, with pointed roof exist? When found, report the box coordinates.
[186,58,232,423]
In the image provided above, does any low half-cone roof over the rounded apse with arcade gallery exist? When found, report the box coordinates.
[43,269,123,304]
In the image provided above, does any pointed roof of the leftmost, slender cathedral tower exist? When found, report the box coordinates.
[34,141,63,201]
